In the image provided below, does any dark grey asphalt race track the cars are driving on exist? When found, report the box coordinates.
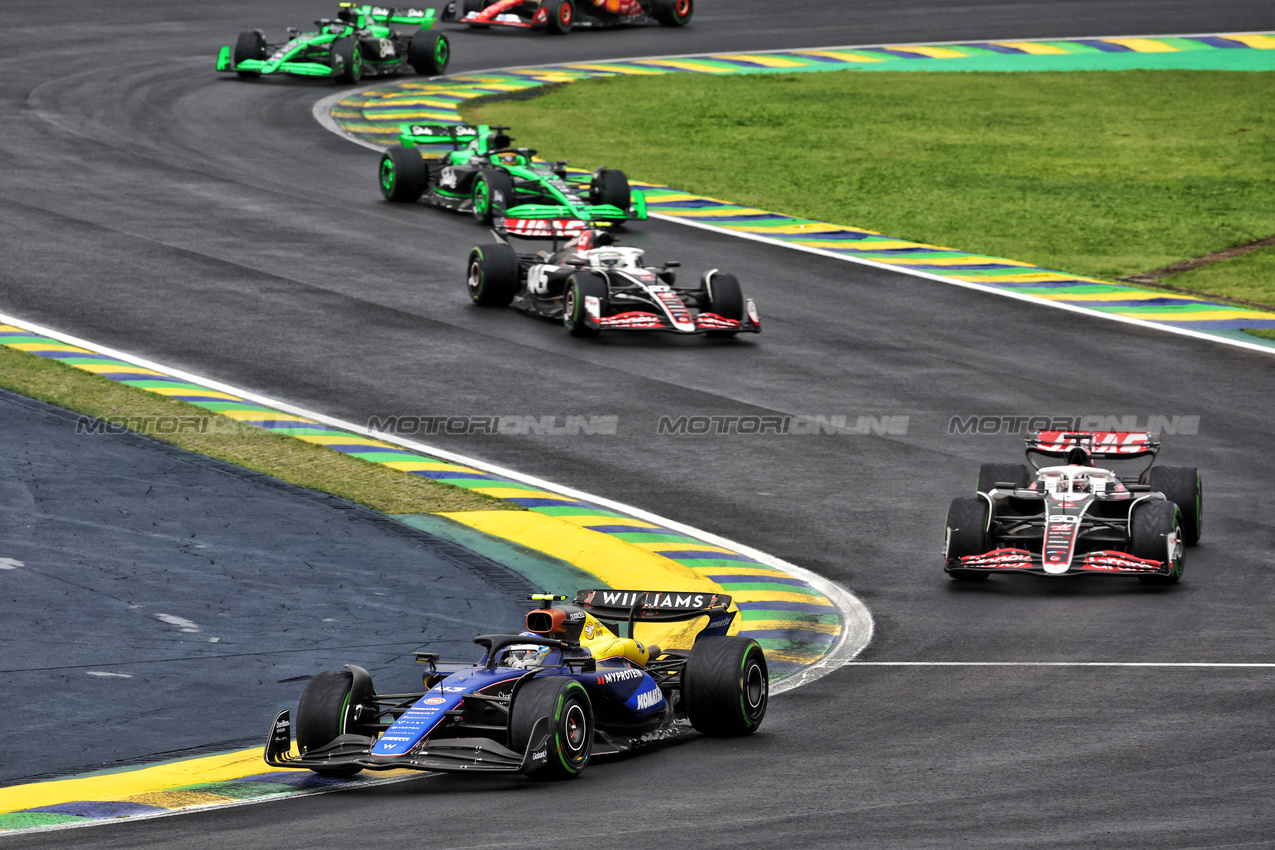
[0,0,1275,847]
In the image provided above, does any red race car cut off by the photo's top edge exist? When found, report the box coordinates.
[441,0,695,36]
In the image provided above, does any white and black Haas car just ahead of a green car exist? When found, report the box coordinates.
[467,228,761,336]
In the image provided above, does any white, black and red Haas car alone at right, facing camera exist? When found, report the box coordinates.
[944,431,1204,584]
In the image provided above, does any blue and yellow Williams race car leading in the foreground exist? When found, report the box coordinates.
[265,589,769,779]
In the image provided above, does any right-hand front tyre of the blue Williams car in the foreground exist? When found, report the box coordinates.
[509,675,594,780]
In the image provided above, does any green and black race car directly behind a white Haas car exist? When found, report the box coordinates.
[379,124,646,228]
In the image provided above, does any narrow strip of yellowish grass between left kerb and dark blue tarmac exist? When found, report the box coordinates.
[0,345,521,514]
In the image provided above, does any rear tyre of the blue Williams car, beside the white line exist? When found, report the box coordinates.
[682,637,770,738]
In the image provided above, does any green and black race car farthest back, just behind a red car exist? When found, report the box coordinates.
[217,3,451,83]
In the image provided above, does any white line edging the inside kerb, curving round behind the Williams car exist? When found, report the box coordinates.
[0,313,872,693]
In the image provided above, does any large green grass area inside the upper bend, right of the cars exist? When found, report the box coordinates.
[463,70,1275,303]
